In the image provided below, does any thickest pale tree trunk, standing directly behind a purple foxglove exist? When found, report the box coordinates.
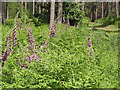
[50,0,55,28]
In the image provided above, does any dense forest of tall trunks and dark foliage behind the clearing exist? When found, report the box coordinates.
[2,1,120,26]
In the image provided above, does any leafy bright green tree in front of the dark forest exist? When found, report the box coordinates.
[63,2,85,24]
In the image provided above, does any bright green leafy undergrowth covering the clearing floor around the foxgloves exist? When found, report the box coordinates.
[2,24,118,88]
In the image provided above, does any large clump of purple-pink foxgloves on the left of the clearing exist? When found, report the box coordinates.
[0,14,47,68]
